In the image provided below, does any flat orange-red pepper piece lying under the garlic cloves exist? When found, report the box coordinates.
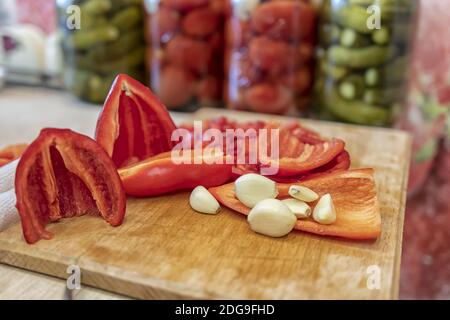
[209,169,381,240]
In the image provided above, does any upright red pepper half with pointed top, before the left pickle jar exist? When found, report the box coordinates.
[96,74,176,168]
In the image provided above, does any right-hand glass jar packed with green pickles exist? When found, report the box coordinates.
[314,0,416,126]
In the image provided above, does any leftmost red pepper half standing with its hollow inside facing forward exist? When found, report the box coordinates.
[15,129,126,244]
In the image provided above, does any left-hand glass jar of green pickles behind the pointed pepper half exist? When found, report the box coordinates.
[57,0,146,103]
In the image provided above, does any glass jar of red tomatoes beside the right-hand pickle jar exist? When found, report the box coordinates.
[224,0,316,114]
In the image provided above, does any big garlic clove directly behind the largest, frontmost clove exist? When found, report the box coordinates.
[234,173,278,208]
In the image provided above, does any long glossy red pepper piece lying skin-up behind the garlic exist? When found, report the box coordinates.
[119,149,232,197]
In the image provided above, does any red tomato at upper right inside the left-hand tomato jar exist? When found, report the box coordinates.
[183,8,220,37]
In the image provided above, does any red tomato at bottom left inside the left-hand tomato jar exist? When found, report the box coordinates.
[156,65,195,109]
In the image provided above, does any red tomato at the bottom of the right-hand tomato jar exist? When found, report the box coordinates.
[244,83,293,114]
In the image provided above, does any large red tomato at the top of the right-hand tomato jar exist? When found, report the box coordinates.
[251,1,316,40]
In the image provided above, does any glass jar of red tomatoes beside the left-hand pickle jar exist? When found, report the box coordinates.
[145,0,225,109]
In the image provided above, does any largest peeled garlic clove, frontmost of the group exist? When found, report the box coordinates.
[247,199,297,238]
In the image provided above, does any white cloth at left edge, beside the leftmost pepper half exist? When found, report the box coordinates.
[0,160,19,232]
